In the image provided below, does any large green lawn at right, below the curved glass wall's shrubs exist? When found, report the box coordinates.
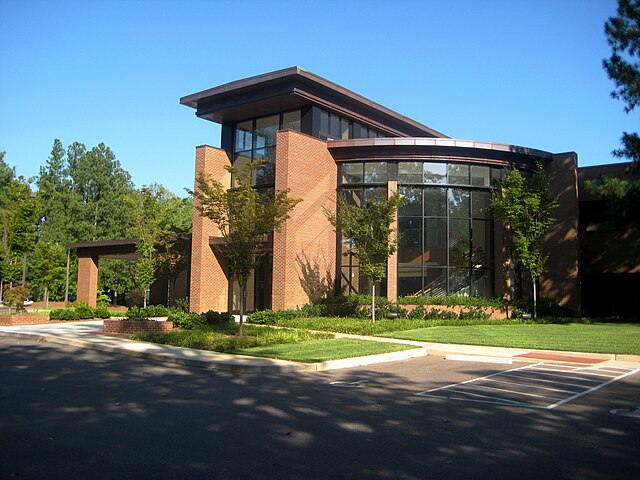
[384,323,640,355]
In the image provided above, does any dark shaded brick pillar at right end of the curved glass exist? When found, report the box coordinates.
[540,152,581,313]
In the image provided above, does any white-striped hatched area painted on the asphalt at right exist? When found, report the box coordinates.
[414,363,640,410]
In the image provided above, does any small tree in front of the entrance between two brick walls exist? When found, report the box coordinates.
[190,162,302,335]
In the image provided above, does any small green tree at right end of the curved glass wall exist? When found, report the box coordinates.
[491,164,559,318]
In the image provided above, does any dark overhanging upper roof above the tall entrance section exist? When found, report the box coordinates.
[180,67,446,138]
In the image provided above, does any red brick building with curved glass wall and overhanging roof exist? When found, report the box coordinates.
[72,67,640,314]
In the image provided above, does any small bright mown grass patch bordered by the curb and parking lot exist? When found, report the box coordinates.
[234,338,417,363]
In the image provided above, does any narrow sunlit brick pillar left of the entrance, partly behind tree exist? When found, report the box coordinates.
[189,145,231,312]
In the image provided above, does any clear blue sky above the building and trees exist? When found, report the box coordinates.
[0,0,637,196]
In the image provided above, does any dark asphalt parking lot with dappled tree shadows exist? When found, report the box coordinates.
[0,338,640,479]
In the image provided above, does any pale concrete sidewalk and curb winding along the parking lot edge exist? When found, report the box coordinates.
[0,320,640,372]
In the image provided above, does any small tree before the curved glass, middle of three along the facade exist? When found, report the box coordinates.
[326,189,401,322]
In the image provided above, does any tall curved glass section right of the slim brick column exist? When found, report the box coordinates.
[398,162,500,296]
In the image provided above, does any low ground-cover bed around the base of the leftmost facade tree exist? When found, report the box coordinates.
[131,325,333,353]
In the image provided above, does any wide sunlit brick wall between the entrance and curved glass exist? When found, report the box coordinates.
[272,130,337,310]
